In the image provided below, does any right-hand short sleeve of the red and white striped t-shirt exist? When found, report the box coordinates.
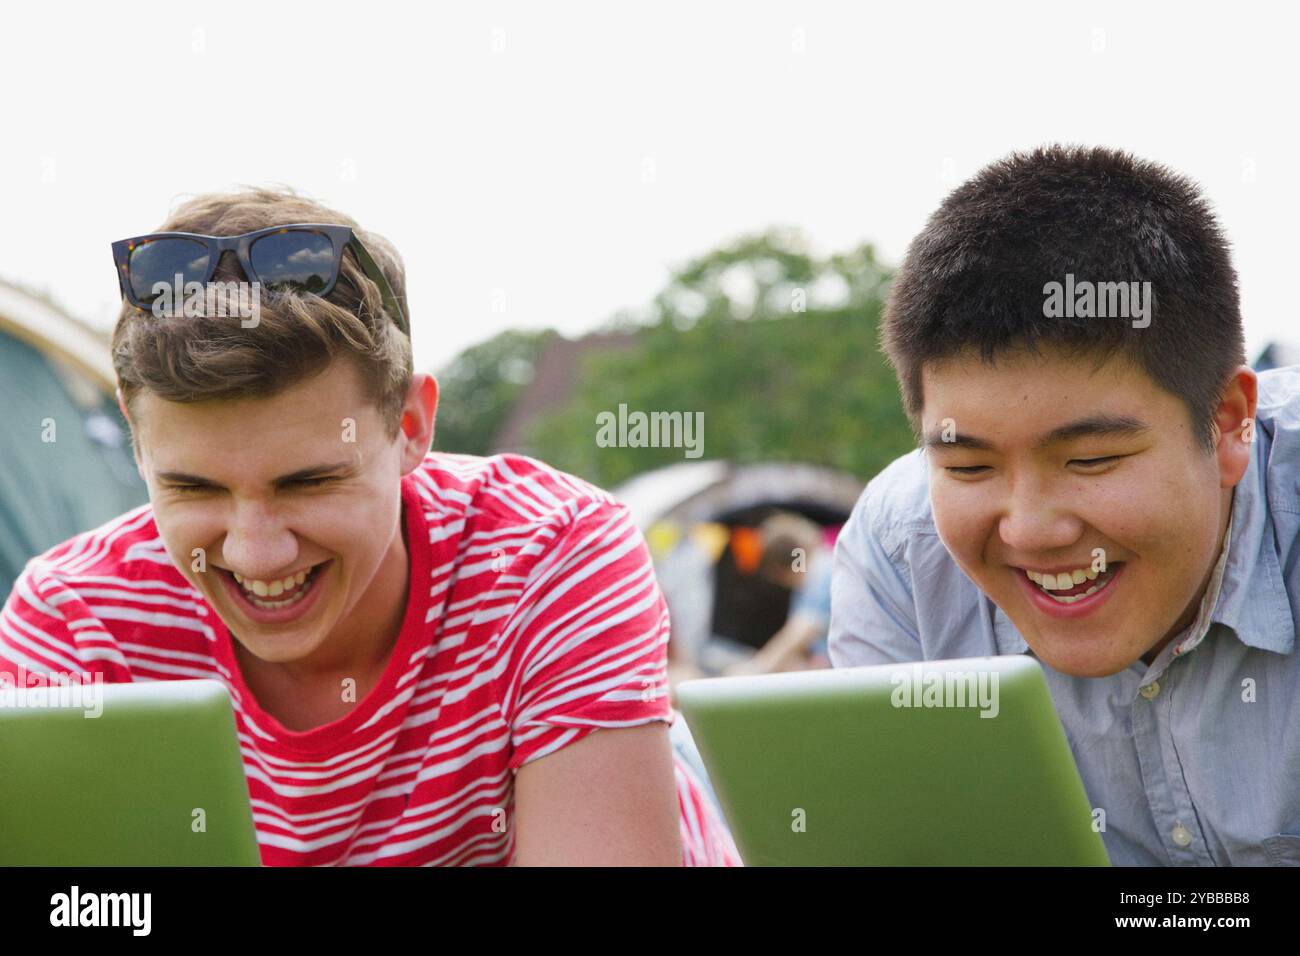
[502,499,672,770]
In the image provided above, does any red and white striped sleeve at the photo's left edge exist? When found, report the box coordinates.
[0,561,131,687]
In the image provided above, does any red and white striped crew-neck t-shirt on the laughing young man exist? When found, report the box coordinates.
[0,453,738,866]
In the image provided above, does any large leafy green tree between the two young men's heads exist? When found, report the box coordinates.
[530,229,914,485]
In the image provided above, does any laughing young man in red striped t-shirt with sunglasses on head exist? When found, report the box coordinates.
[0,190,736,865]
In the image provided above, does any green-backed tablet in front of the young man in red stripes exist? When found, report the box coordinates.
[0,680,261,866]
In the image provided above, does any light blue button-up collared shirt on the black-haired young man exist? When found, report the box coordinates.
[829,365,1300,866]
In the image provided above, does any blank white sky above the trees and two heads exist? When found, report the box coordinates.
[0,0,1300,368]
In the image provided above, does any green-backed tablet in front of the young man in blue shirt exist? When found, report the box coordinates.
[677,656,1109,866]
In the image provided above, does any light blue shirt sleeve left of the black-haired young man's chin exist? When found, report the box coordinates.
[828,485,923,667]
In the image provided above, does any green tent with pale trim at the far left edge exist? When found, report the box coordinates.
[0,281,148,602]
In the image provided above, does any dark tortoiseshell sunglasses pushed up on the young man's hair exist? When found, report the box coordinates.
[113,222,411,336]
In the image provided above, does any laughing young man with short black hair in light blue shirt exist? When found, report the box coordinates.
[829,147,1300,865]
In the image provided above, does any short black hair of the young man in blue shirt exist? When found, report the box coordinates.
[881,144,1245,450]
